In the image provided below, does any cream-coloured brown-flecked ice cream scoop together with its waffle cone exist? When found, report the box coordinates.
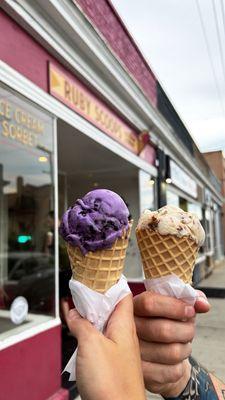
[136,206,205,283]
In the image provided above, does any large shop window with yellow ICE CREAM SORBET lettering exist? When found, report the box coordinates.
[0,87,55,339]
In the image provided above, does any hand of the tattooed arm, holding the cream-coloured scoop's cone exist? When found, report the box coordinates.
[134,291,210,397]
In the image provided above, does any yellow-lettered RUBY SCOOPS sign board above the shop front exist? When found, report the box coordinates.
[49,63,139,154]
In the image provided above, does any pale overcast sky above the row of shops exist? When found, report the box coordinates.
[113,0,225,151]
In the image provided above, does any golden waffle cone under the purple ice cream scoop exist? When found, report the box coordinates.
[67,224,132,293]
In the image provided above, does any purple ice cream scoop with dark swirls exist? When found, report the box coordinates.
[59,189,129,254]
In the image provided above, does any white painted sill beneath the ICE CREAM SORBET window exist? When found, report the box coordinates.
[0,318,61,351]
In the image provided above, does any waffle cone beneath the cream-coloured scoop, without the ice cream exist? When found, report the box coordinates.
[136,229,198,283]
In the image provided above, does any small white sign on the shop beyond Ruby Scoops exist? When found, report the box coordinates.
[170,160,198,198]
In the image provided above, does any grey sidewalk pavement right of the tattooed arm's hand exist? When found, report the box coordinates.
[193,262,225,382]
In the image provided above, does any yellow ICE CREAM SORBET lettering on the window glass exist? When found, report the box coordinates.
[0,98,44,147]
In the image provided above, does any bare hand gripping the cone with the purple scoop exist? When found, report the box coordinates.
[64,295,145,400]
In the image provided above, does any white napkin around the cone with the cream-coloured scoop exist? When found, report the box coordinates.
[144,274,197,306]
